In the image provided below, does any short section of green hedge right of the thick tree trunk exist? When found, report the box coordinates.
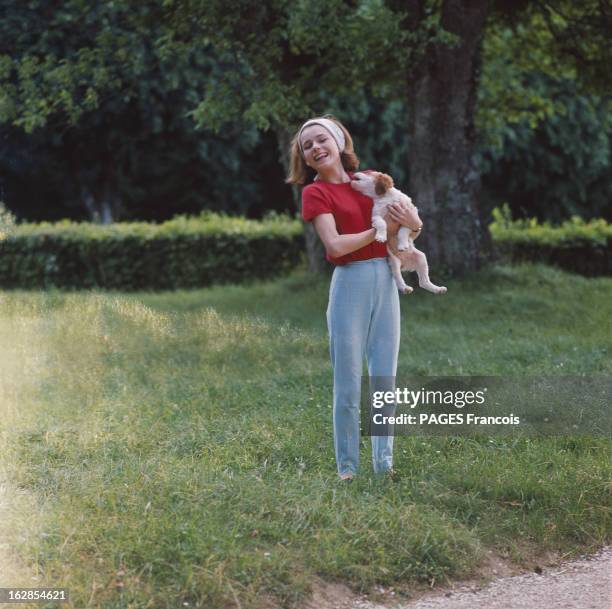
[490,206,612,276]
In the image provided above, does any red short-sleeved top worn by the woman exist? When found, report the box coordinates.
[302,173,387,265]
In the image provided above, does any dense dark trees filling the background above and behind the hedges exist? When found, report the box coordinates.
[0,0,611,272]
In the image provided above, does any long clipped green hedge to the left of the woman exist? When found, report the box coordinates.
[0,214,304,290]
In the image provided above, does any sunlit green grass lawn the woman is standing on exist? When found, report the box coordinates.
[0,266,612,609]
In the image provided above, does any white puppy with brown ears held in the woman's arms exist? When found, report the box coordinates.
[351,171,446,294]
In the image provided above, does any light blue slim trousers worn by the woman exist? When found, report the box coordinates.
[327,258,400,476]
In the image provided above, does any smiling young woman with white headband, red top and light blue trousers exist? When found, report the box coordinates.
[287,115,410,481]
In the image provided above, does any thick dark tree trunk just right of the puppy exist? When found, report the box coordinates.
[407,0,490,276]
